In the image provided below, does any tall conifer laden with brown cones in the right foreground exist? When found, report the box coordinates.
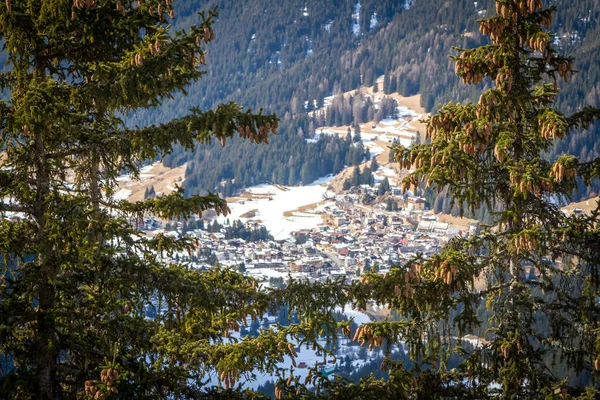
[395,0,600,398]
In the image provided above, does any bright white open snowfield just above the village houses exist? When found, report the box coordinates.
[220,175,333,240]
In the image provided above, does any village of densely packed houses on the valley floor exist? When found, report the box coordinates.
[146,194,475,285]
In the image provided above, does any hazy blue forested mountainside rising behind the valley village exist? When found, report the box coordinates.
[129,0,600,200]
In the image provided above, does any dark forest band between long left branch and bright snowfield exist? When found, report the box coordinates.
[165,122,370,196]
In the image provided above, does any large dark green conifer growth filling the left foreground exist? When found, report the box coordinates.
[0,0,281,400]
